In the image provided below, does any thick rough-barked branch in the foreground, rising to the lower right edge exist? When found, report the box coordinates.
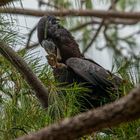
[17,87,140,140]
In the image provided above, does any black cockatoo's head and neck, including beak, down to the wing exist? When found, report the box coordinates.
[37,16,83,63]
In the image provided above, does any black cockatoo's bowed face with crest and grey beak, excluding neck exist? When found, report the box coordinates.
[37,16,61,61]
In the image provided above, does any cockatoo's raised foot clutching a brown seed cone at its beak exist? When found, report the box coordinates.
[47,54,67,68]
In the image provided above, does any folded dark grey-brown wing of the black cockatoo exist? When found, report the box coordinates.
[66,57,114,88]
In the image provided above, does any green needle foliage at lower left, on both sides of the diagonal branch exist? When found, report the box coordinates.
[0,50,83,140]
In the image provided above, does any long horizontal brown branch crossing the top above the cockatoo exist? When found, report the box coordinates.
[0,8,140,20]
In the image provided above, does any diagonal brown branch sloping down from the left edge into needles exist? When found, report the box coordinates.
[0,42,48,108]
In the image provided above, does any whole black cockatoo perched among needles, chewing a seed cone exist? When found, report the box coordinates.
[37,16,122,108]
